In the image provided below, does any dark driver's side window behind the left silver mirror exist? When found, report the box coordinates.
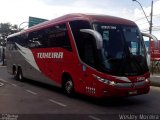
[70,20,95,67]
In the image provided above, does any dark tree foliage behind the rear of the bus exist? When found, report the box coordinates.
[0,23,19,46]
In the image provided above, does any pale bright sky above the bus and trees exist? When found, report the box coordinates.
[0,0,160,40]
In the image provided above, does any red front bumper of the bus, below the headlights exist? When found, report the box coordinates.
[98,81,150,97]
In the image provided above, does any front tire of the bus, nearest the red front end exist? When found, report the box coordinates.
[63,77,74,97]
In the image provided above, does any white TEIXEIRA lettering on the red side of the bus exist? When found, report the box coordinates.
[37,52,63,59]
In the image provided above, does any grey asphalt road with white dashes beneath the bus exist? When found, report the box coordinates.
[0,66,160,120]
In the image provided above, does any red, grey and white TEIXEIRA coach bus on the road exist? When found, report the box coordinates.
[6,14,154,97]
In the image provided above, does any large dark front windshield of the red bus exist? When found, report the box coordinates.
[93,23,148,76]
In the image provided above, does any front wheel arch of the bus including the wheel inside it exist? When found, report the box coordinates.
[62,73,74,97]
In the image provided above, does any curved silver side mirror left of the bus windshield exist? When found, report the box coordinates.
[80,29,103,50]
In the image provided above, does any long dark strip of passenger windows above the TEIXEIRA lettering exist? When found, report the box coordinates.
[8,24,72,51]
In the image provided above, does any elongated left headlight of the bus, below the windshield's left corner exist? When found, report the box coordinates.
[93,74,116,86]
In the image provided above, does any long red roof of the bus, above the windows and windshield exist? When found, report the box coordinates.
[10,13,136,37]
